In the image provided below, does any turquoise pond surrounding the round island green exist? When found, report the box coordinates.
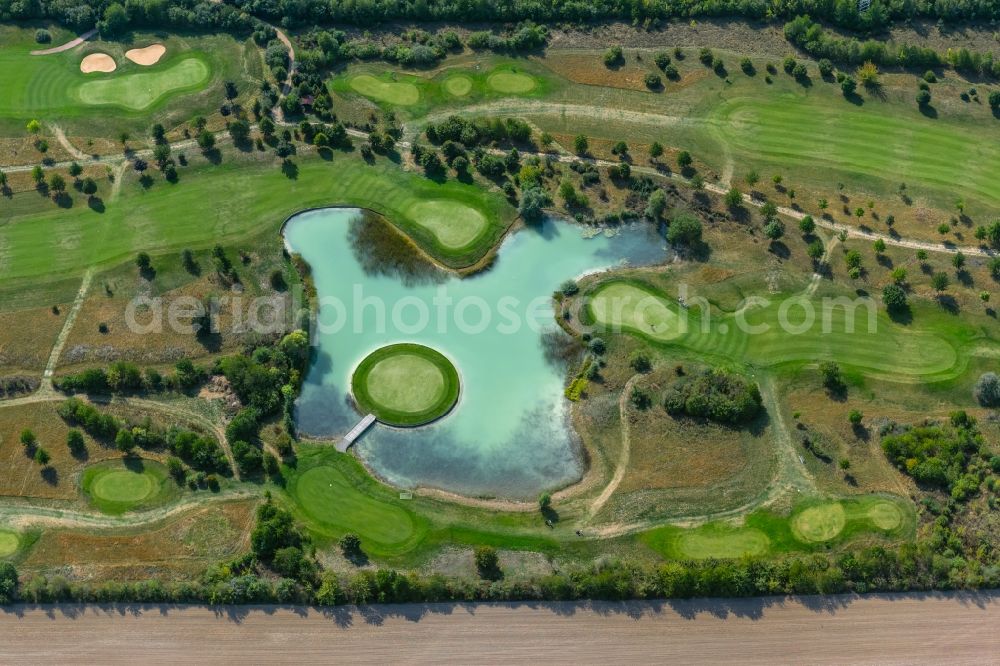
[285,208,667,498]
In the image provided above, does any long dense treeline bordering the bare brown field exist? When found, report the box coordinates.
[0,540,1000,606]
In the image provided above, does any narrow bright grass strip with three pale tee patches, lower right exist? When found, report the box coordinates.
[639,495,916,560]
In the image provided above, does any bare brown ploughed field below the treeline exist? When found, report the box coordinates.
[0,593,1000,666]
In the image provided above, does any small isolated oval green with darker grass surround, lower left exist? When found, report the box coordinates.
[80,458,177,515]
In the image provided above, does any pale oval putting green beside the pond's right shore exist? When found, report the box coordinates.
[590,282,687,340]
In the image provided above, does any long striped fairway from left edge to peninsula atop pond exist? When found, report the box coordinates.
[0,153,517,287]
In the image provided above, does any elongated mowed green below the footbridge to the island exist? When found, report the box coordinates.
[293,465,416,545]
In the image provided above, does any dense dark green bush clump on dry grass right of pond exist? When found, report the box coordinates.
[663,369,763,424]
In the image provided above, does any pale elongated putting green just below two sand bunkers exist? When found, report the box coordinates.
[77,57,211,111]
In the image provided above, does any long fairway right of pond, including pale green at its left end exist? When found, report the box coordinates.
[584,277,997,381]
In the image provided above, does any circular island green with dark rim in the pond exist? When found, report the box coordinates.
[351,343,459,426]
